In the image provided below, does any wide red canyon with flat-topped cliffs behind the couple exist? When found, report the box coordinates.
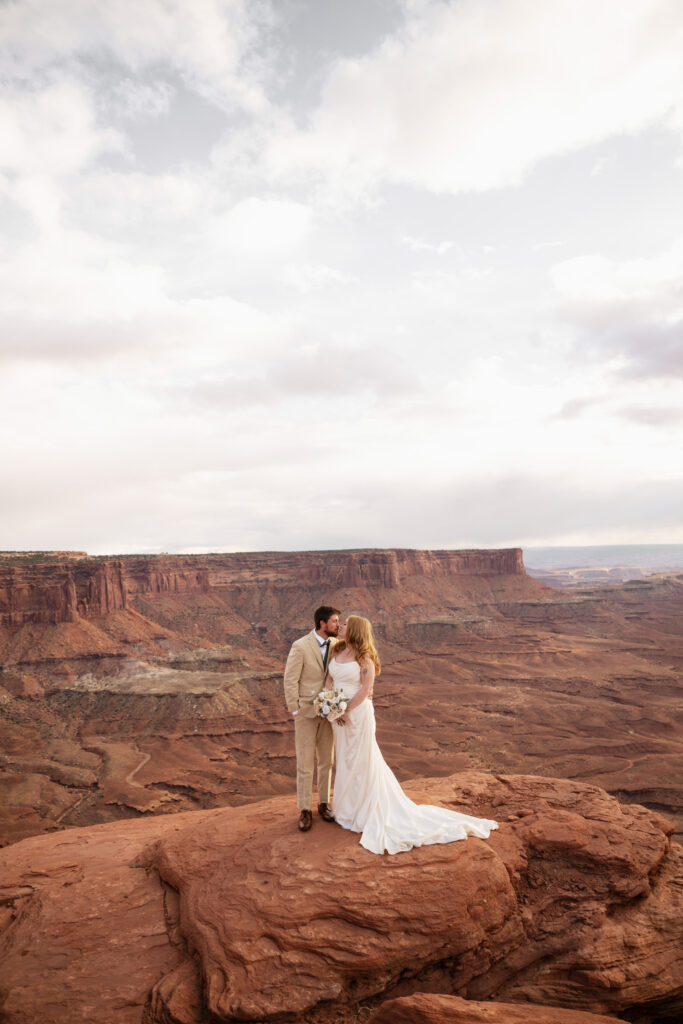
[0,549,683,844]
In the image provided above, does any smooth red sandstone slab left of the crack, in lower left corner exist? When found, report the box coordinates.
[0,812,194,1024]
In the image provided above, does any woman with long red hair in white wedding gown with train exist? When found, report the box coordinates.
[326,615,498,853]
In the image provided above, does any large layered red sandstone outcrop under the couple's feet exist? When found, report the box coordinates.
[0,773,683,1024]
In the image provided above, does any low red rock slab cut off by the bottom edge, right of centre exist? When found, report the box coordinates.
[372,993,625,1024]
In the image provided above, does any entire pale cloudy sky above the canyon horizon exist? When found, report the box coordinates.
[0,0,683,553]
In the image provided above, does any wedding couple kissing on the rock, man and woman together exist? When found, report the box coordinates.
[285,604,498,854]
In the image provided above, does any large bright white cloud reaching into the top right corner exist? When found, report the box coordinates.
[268,0,683,193]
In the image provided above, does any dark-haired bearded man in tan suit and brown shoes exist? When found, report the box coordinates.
[285,604,340,831]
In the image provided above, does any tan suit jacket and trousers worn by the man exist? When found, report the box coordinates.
[285,630,335,811]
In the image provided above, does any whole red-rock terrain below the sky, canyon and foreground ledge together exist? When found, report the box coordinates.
[0,549,683,1024]
